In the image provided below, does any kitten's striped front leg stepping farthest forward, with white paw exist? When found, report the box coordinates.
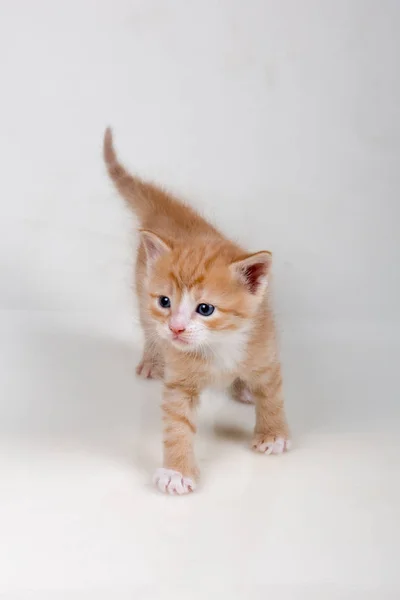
[154,380,199,494]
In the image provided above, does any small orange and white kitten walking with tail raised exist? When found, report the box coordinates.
[104,129,290,494]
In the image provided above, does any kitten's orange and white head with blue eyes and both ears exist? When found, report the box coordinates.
[141,231,271,352]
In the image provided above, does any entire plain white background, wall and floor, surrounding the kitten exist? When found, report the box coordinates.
[0,0,400,598]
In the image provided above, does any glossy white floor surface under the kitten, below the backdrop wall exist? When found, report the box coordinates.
[0,311,400,600]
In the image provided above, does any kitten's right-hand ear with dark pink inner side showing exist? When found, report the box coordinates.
[230,250,272,295]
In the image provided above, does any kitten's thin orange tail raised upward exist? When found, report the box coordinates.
[103,127,155,222]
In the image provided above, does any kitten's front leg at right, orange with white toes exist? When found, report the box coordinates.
[252,361,290,454]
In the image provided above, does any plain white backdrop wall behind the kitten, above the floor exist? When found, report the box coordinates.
[0,0,400,323]
